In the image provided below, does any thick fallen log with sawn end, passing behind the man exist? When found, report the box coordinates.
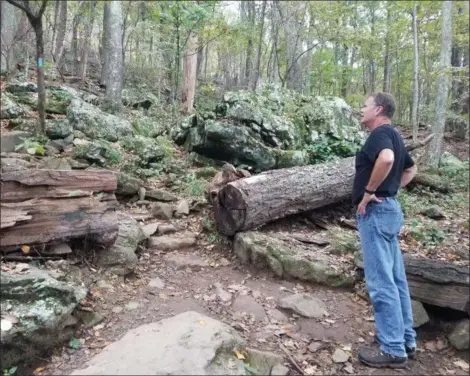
[213,137,431,236]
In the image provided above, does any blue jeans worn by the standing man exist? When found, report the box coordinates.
[356,197,416,356]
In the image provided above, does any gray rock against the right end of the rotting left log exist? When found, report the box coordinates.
[97,213,147,275]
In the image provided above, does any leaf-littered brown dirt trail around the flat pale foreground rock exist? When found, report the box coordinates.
[37,213,468,375]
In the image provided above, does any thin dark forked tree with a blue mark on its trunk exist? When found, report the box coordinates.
[7,0,48,133]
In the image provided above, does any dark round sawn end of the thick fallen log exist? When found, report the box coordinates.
[214,184,246,236]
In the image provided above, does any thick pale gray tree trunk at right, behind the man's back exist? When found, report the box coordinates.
[427,0,452,168]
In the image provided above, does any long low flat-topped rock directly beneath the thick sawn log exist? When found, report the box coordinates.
[233,231,356,287]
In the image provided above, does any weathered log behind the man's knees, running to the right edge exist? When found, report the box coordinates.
[405,255,470,314]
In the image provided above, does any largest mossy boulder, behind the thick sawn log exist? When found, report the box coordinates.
[170,90,364,171]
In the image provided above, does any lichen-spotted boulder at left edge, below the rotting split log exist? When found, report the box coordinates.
[0,264,87,369]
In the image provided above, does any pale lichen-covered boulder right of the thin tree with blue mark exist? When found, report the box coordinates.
[67,98,132,142]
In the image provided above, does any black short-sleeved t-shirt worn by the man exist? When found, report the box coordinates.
[352,124,414,205]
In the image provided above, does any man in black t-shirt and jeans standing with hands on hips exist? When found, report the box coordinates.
[352,92,417,368]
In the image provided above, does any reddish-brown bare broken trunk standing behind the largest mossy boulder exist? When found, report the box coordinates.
[181,31,198,113]
